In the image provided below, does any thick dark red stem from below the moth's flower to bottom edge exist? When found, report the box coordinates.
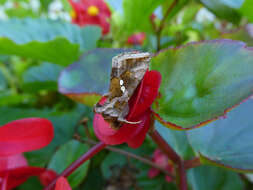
[149,130,187,190]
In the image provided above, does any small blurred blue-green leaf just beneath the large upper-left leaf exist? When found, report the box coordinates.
[23,63,63,92]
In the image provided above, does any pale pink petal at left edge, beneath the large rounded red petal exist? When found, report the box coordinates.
[0,154,28,171]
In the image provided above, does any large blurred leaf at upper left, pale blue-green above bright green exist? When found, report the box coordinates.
[0,18,100,65]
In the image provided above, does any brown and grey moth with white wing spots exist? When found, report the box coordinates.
[94,51,151,129]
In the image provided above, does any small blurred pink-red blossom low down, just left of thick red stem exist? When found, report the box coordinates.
[148,149,173,182]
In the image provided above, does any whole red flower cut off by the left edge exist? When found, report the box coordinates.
[0,118,54,190]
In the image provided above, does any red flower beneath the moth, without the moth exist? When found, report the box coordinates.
[93,71,161,148]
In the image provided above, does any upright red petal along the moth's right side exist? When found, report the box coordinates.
[127,71,162,120]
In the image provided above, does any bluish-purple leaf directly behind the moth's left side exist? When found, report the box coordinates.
[58,49,129,106]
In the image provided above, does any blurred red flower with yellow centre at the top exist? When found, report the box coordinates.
[69,0,111,34]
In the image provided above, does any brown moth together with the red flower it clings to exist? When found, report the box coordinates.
[93,52,161,148]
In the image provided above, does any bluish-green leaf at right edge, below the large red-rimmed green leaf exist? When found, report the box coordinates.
[187,99,253,172]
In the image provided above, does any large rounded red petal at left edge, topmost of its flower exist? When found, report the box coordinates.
[0,118,54,156]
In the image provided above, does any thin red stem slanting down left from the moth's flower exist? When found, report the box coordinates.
[44,142,106,190]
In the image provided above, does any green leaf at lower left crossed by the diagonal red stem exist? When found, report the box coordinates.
[48,140,90,188]
